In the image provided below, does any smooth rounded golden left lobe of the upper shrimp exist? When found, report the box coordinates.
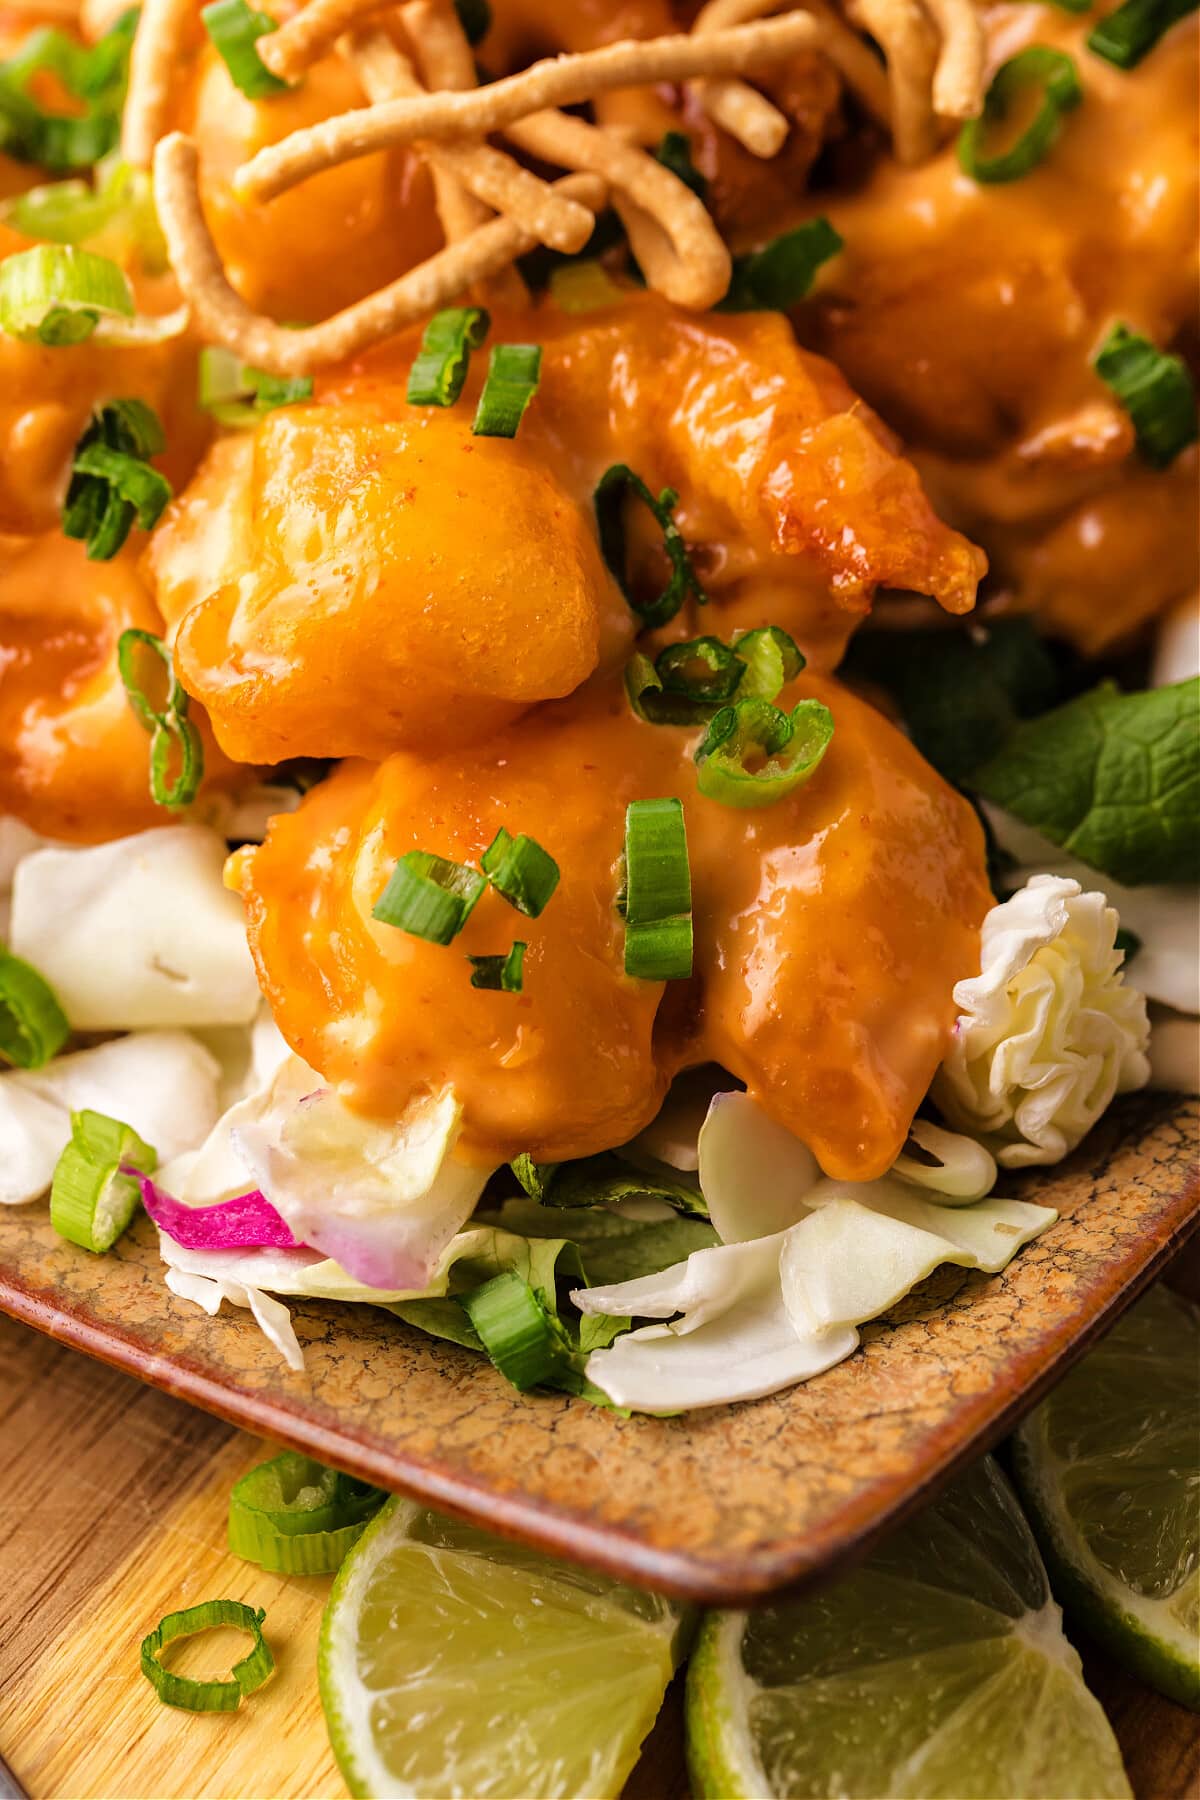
[149,401,628,761]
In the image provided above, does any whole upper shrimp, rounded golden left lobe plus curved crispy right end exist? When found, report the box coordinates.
[149,295,982,761]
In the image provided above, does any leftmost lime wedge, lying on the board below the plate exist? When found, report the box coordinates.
[318,1499,687,1800]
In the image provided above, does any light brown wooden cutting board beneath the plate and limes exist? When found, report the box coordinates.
[0,1318,1200,1800]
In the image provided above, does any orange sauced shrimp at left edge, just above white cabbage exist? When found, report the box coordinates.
[0,533,212,844]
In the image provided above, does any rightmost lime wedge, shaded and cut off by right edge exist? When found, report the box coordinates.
[1013,1287,1200,1710]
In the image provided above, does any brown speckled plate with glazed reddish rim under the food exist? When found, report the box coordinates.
[0,1094,1200,1604]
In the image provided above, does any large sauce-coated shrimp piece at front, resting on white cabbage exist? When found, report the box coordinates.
[239,675,990,1179]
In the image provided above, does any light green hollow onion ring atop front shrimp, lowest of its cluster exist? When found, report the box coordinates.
[694,698,833,806]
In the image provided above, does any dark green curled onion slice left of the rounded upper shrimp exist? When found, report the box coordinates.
[63,400,171,562]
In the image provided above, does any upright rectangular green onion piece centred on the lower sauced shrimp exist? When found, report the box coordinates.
[624,797,693,981]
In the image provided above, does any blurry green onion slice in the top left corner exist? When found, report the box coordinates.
[0,11,137,173]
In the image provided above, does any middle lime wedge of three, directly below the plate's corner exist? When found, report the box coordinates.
[687,1458,1130,1800]
